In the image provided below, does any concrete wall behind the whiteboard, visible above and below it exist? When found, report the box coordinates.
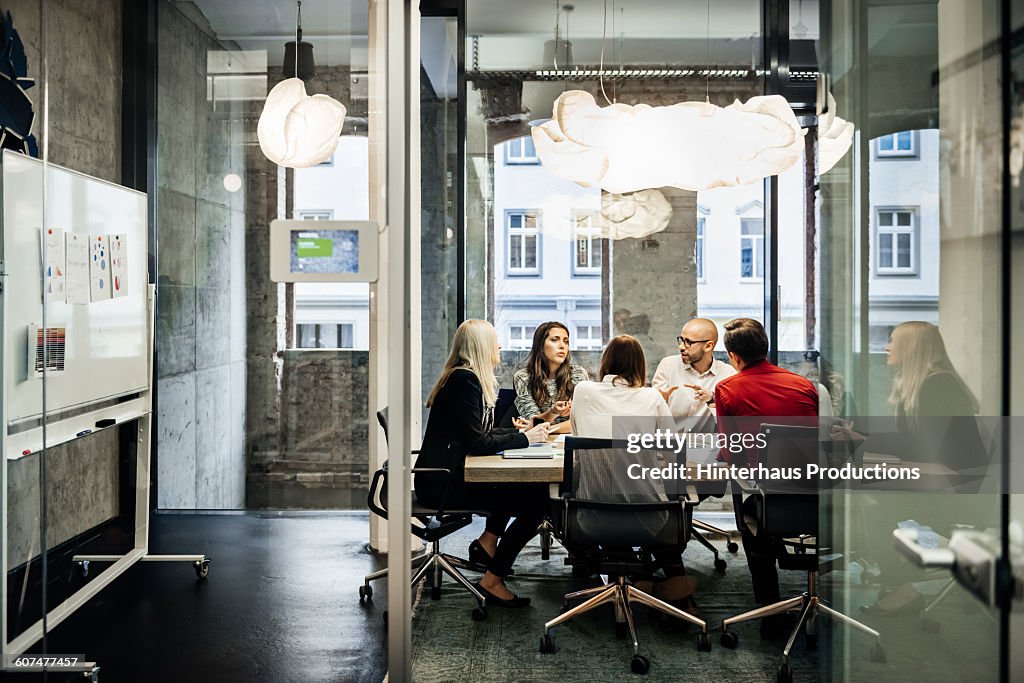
[0,0,121,566]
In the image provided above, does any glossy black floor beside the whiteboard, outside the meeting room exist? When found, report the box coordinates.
[4,512,387,683]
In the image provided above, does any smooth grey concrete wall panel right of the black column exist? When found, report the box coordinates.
[156,2,246,509]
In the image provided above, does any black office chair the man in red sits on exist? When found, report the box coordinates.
[721,424,886,683]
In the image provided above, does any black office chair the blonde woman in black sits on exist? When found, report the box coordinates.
[359,408,487,624]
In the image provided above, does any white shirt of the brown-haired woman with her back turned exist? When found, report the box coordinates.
[569,375,675,438]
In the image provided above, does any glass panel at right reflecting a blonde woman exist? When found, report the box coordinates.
[815,1,1010,681]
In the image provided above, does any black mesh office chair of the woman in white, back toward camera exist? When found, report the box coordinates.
[540,436,711,674]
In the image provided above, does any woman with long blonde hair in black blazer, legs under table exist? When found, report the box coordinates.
[415,321,550,607]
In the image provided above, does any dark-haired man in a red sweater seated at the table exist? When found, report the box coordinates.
[715,317,818,635]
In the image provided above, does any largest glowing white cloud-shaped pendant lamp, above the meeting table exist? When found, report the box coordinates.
[532,90,805,195]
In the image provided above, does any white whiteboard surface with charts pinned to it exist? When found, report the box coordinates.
[0,152,150,424]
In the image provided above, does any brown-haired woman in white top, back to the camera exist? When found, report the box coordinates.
[569,335,696,609]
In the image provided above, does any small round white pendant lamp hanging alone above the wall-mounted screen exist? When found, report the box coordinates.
[256,78,345,168]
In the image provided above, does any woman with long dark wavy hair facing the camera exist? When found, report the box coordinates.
[512,323,590,433]
